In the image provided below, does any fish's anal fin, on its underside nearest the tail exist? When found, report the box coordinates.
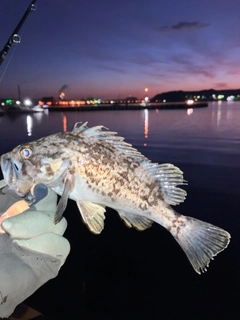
[118,211,153,231]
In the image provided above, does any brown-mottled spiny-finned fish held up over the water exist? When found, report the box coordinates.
[1,122,231,274]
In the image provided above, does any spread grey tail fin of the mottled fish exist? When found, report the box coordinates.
[170,215,231,274]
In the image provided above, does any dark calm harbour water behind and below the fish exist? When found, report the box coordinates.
[0,102,240,320]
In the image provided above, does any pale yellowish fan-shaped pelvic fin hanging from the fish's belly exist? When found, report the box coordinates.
[77,201,106,234]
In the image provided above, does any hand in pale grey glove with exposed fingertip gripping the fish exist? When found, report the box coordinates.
[0,181,70,318]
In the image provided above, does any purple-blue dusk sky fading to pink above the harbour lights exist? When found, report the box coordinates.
[0,0,240,99]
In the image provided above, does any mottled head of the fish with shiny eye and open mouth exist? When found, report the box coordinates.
[1,136,72,196]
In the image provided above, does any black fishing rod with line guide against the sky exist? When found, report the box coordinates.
[0,0,37,65]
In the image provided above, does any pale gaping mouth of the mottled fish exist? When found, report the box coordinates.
[1,153,25,196]
